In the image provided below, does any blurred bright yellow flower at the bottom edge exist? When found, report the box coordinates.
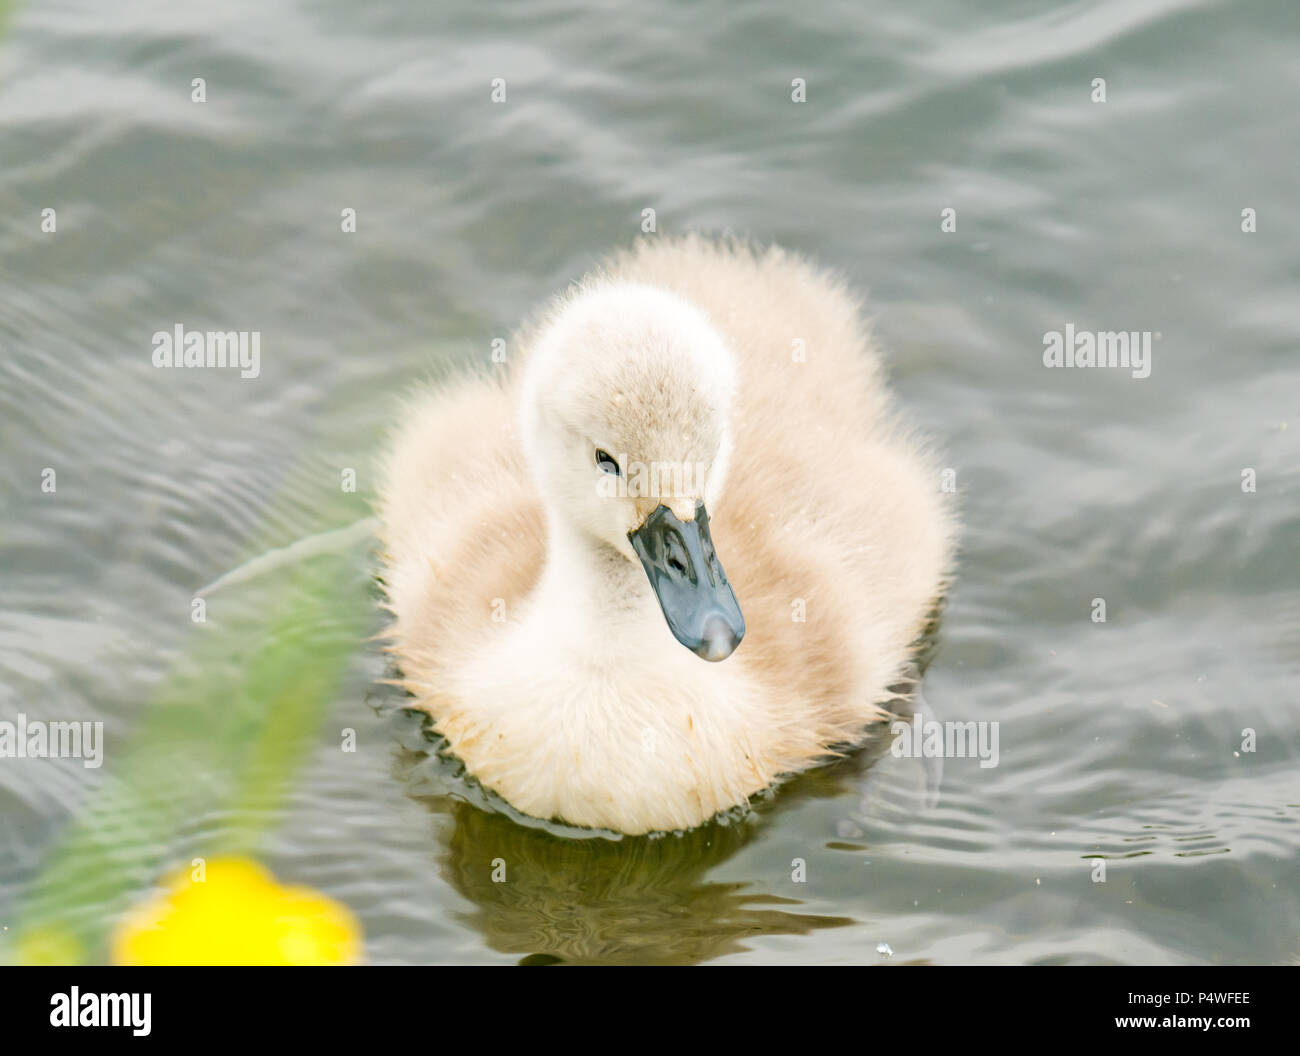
[109,858,361,965]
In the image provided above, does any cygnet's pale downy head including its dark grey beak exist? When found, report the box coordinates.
[520,282,745,661]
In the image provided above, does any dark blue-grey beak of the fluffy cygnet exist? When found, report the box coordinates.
[628,502,745,661]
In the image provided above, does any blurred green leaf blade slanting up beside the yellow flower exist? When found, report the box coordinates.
[10,491,374,964]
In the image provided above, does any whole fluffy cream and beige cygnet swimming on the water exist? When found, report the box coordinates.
[380,237,954,834]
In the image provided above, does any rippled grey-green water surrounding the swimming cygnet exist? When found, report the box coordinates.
[0,0,1300,964]
